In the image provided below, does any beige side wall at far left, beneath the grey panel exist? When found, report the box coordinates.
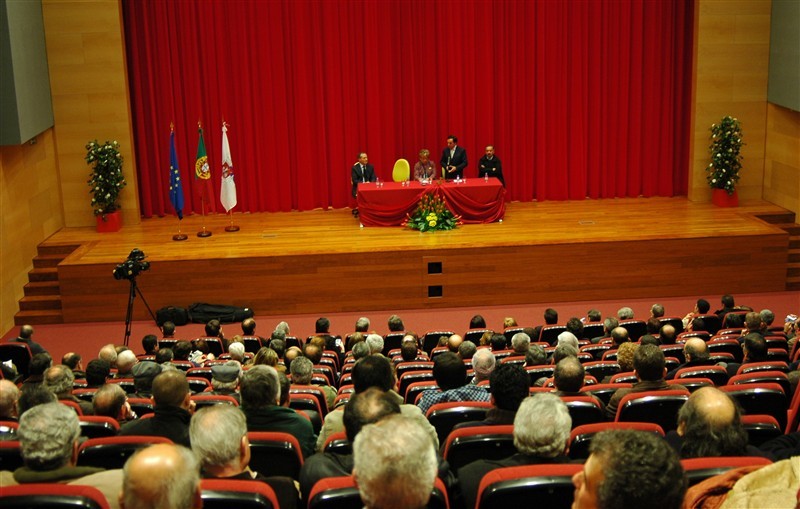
[0,129,64,333]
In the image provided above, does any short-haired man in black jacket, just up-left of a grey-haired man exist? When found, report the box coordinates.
[119,370,195,447]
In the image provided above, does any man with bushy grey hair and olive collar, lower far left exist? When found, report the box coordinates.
[8,402,103,484]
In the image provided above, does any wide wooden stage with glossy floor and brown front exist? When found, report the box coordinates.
[43,198,788,323]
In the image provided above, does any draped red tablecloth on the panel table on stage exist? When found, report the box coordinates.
[358,178,506,226]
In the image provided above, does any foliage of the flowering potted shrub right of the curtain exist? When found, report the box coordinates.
[706,117,744,195]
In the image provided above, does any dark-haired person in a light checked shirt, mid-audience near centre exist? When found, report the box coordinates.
[417,352,490,414]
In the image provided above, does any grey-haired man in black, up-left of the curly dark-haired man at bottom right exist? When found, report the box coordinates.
[458,393,572,507]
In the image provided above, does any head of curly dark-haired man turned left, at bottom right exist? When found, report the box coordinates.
[572,430,687,509]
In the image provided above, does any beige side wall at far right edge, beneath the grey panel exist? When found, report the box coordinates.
[764,104,800,216]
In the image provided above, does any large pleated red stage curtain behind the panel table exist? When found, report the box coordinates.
[122,0,694,217]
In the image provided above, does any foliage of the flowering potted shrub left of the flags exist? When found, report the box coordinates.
[85,140,127,221]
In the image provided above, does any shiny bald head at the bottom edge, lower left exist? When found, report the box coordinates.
[119,444,203,509]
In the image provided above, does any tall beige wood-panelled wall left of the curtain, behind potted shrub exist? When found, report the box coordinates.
[42,0,141,226]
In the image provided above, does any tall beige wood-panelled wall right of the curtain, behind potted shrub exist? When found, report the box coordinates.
[689,0,772,201]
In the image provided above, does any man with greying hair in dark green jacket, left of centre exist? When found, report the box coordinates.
[240,366,316,458]
